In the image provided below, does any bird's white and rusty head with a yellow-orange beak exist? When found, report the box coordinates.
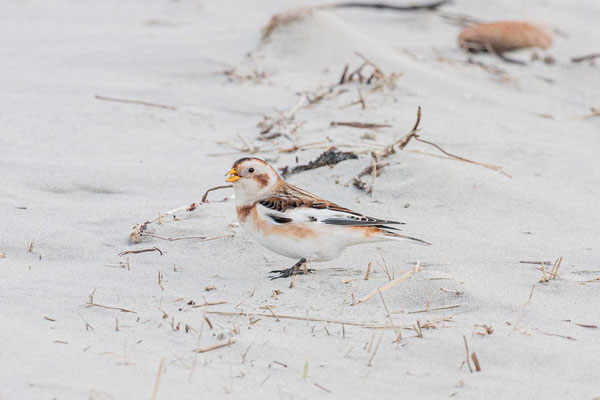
[226,157,281,204]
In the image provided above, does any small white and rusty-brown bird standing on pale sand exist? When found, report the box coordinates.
[226,157,431,279]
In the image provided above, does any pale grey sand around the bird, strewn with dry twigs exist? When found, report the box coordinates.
[0,0,600,400]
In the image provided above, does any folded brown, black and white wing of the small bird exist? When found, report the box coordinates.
[258,184,403,230]
